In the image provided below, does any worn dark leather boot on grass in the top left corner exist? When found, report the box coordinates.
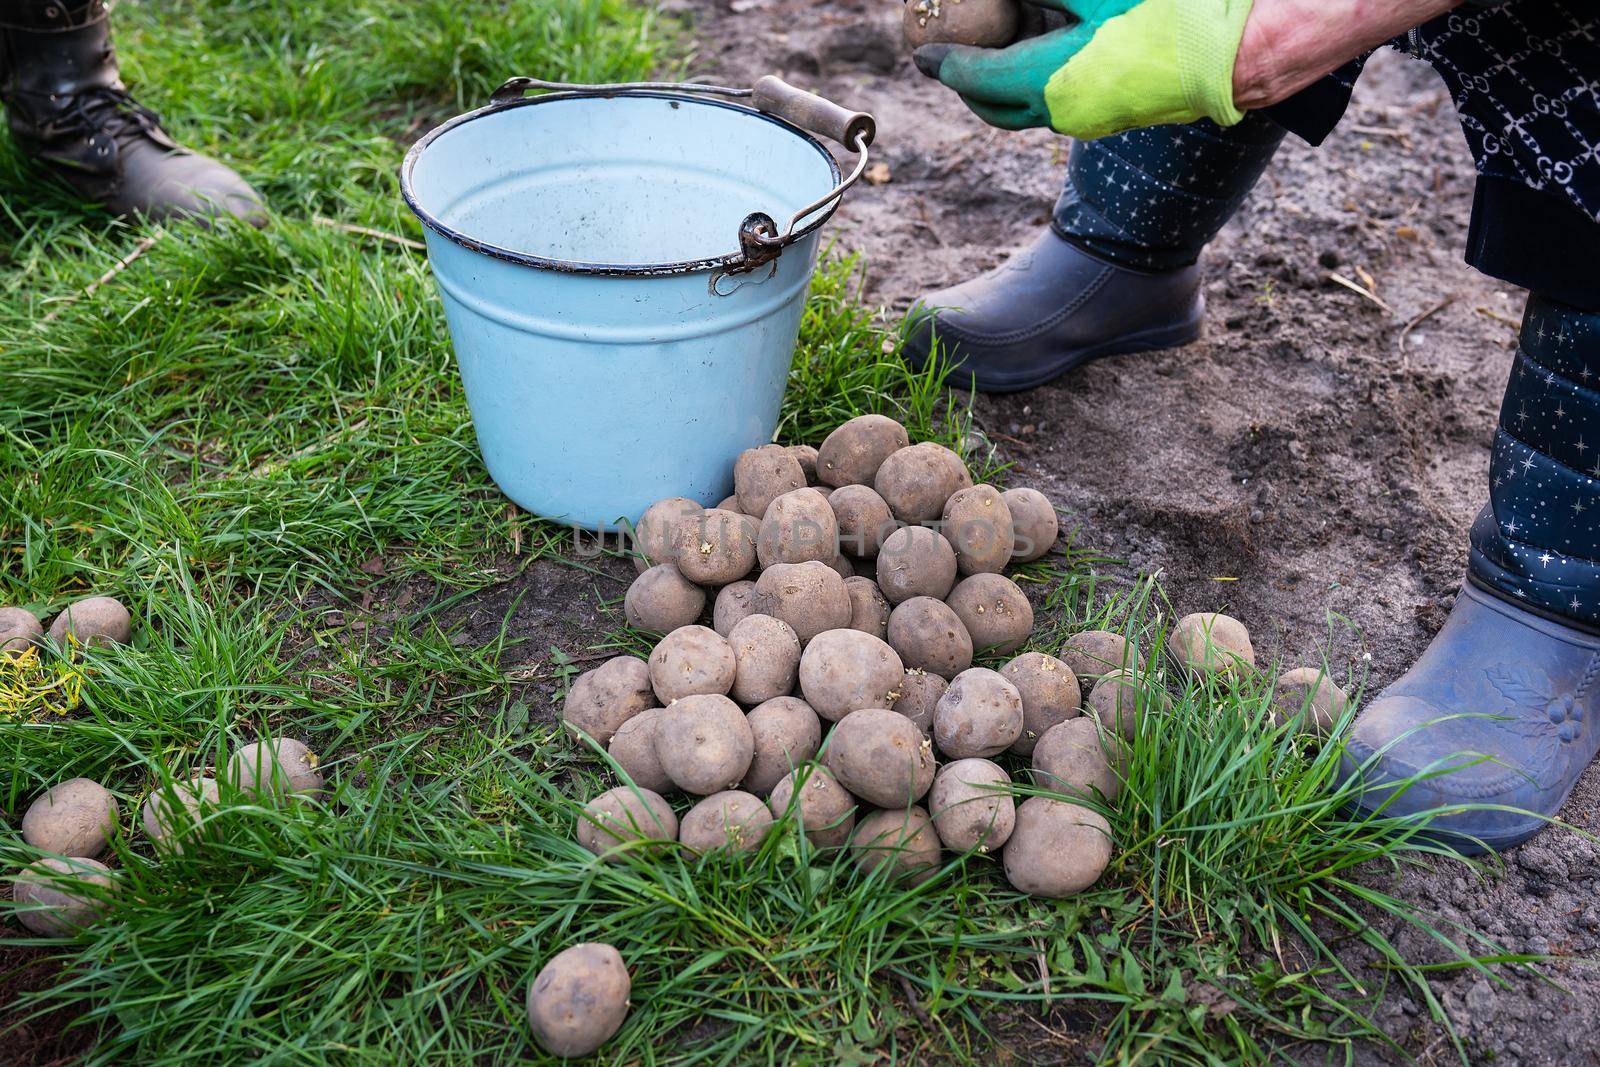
[0,0,267,226]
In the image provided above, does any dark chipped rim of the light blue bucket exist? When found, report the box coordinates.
[400,90,843,278]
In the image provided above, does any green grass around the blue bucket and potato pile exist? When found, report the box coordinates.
[0,0,1529,1064]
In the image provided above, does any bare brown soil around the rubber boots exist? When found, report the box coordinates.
[656,0,1600,1064]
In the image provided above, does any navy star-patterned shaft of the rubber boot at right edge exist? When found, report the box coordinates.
[1467,296,1600,629]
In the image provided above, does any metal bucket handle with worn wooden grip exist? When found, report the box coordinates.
[490,74,878,274]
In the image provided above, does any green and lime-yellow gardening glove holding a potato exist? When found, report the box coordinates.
[912,0,1254,139]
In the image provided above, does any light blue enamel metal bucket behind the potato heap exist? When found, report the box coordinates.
[402,78,870,530]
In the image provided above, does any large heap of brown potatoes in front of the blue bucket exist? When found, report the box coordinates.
[562,414,1142,897]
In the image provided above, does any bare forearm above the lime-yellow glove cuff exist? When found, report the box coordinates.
[1234,0,1461,110]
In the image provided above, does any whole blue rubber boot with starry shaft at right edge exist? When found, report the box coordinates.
[1344,296,1600,853]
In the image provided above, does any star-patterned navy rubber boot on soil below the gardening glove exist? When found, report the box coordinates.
[906,115,1283,392]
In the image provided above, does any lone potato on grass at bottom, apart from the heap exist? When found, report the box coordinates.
[528,941,634,1057]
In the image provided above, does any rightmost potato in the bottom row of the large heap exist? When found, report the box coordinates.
[1005,797,1110,897]
